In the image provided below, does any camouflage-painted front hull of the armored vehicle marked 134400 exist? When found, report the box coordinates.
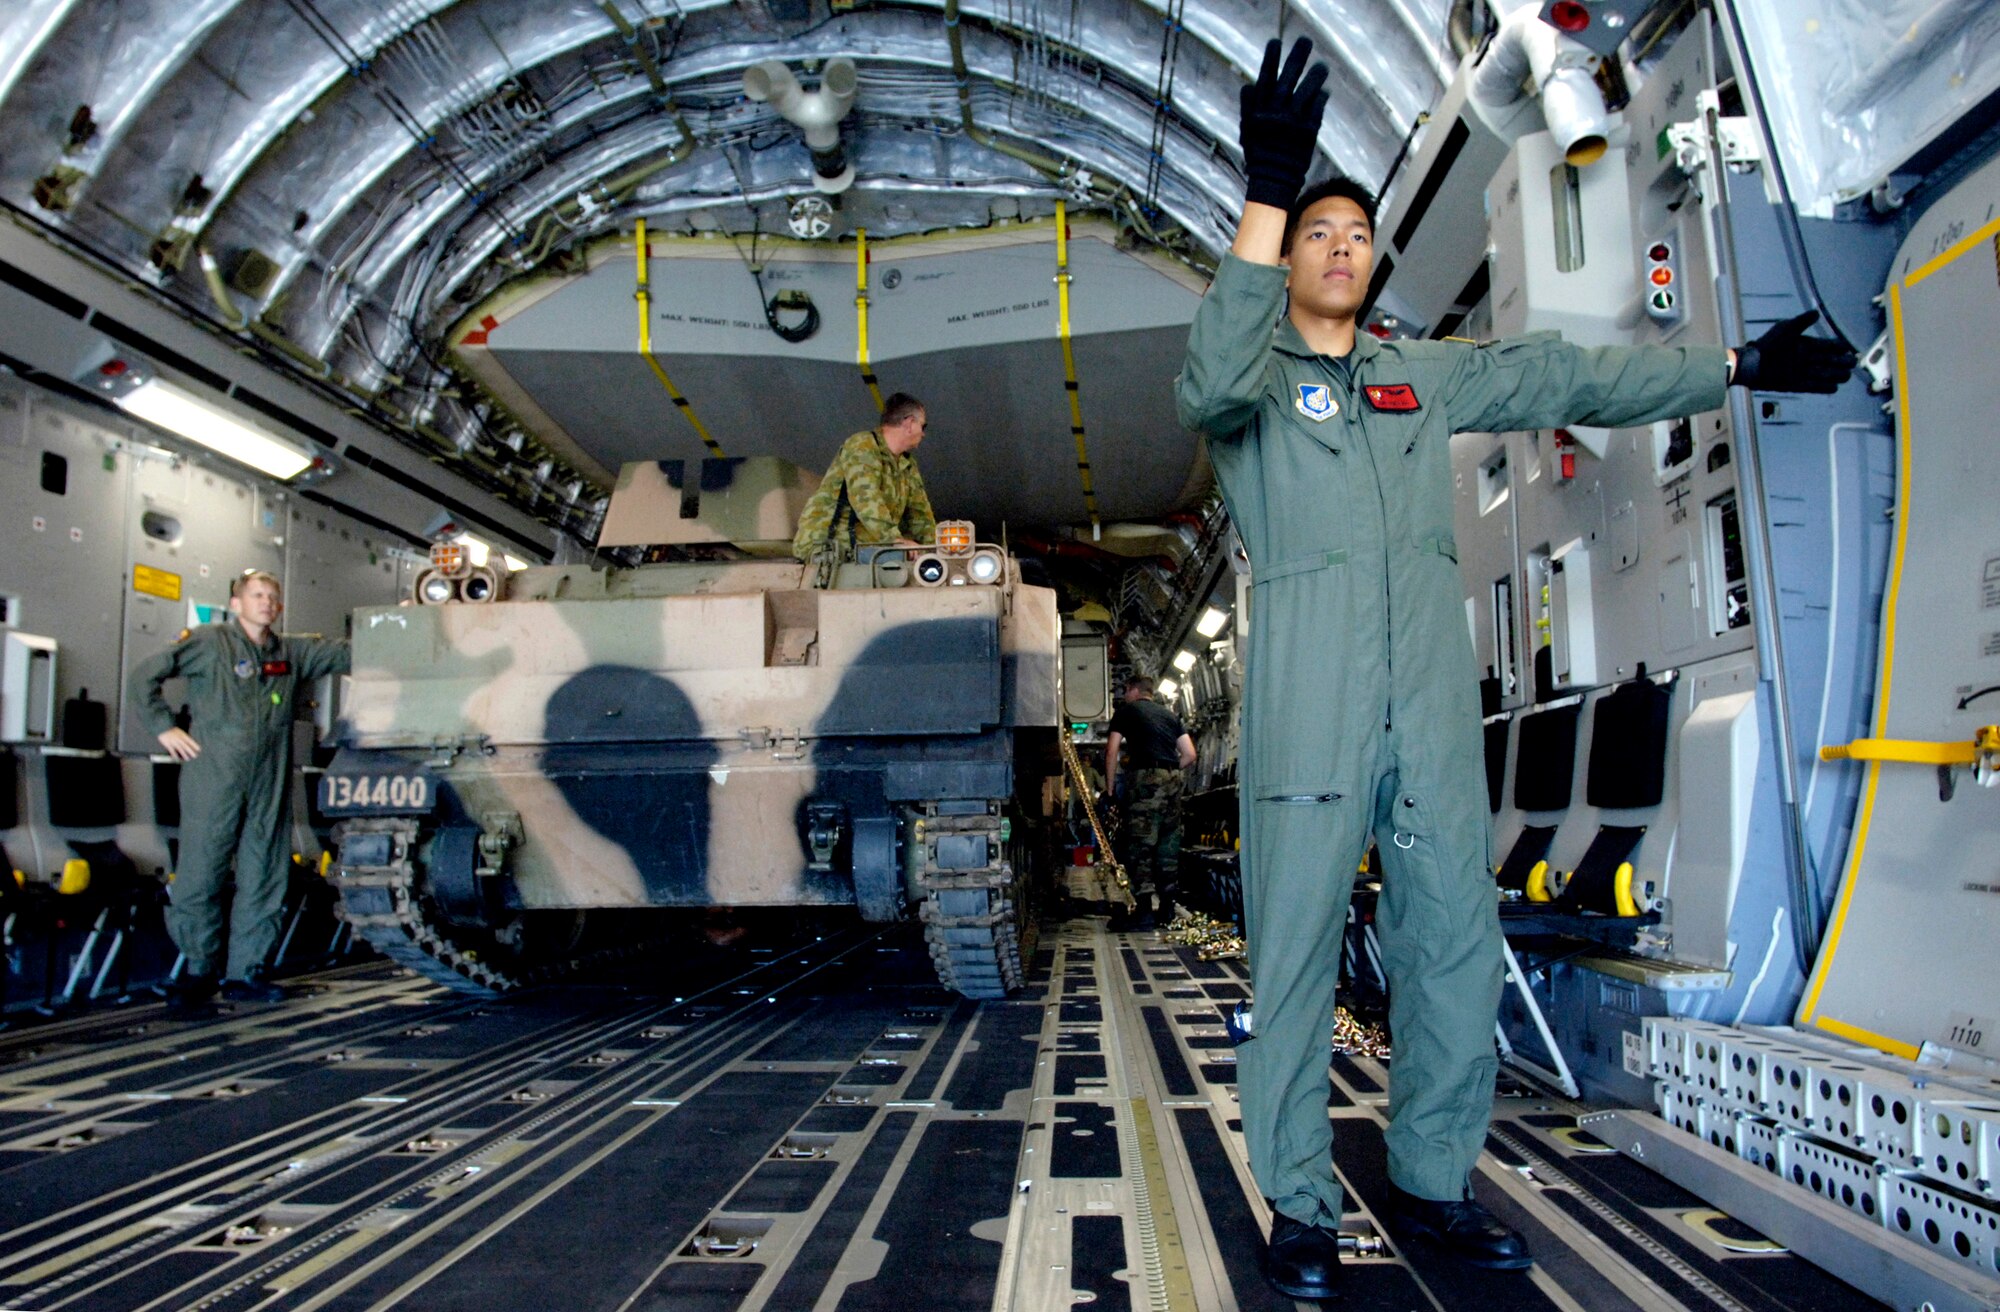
[328,462,1060,1000]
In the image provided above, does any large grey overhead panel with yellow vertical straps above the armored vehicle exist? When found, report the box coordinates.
[456,222,1204,524]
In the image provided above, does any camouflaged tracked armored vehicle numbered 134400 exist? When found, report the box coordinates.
[320,458,1060,998]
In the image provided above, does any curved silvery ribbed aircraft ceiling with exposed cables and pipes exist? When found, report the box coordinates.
[0,0,1468,540]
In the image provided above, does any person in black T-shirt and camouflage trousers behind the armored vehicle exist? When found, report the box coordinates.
[1104,676,1194,930]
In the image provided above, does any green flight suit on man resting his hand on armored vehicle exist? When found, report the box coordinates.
[128,618,348,980]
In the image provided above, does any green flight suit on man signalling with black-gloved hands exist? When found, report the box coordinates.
[1176,256,1726,1226]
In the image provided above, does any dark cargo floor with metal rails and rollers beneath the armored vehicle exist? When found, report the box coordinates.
[0,918,1876,1312]
